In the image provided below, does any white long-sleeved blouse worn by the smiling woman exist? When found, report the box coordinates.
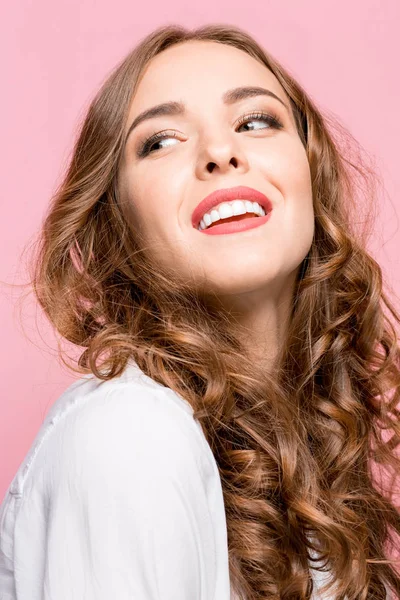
[0,360,376,600]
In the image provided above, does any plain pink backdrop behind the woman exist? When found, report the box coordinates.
[0,0,400,497]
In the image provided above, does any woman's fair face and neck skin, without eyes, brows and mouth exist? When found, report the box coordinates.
[120,41,314,368]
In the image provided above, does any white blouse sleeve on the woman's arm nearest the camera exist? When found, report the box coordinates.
[15,385,215,600]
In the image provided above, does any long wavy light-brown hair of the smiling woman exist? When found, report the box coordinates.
[23,24,400,600]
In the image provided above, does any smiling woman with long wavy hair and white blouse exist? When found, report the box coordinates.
[0,25,400,600]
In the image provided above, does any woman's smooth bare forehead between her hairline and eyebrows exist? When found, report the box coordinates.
[131,40,287,112]
